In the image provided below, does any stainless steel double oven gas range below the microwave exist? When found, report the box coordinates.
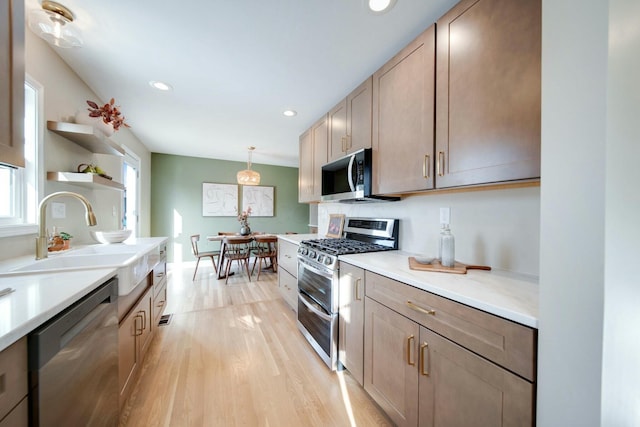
[298,218,399,370]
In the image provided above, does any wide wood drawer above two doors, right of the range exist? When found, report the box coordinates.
[365,271,536,381]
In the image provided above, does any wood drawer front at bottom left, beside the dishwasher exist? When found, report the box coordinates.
[0,337,27,420]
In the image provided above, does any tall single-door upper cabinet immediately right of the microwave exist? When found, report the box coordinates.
[372,26,435,194]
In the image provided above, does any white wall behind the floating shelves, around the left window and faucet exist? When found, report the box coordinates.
[0,30,151,259]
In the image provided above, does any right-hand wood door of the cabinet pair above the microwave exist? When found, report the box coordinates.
[345,77,373,154]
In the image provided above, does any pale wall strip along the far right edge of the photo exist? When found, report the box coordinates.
[602,0,640,426]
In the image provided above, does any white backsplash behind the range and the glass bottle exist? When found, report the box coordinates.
[318,187,540,276]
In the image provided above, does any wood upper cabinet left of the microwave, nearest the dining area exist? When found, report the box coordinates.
[298,116,328,203]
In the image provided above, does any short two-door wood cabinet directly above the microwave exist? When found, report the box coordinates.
[328,77,372,161]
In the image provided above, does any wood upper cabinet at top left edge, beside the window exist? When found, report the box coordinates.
[0,0,25,167]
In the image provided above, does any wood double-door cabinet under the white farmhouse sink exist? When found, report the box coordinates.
[118,287,155,409]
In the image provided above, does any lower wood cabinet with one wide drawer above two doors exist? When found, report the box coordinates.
[364,272,536,427]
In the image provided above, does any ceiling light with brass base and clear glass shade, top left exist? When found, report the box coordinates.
[29,0,82,48]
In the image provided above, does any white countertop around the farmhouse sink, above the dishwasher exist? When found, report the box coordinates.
[0,237,167,351]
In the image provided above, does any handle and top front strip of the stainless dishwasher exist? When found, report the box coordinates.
[28,277,118,371]
